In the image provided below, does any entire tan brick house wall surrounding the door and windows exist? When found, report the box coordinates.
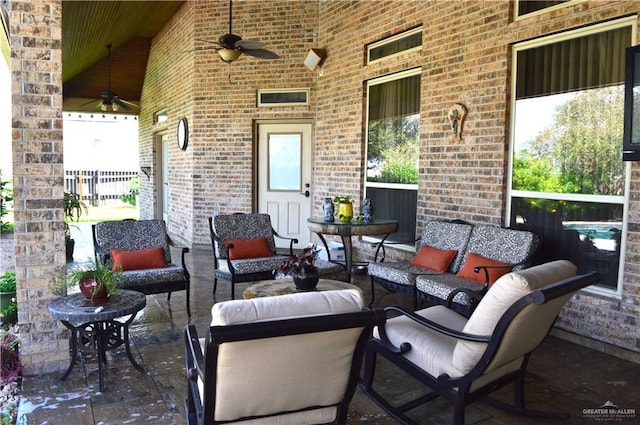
[140,0,640,358]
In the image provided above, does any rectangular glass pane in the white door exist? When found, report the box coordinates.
[267,134,302,191]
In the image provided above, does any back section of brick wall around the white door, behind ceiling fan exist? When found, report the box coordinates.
[140,0,318,245]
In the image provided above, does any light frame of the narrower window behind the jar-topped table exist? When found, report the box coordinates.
[362,67,423,248]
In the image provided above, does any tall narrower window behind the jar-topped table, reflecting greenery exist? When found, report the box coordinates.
[365,69,421,241]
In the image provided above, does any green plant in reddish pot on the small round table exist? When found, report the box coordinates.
[49,260,125,305]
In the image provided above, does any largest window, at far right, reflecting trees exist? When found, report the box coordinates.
[507,18,635,295]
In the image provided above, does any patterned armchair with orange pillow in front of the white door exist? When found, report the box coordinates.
[209,213,298,299]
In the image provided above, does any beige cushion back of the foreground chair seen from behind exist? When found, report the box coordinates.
[206,290,363,425]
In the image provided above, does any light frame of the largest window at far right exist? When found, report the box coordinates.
[505,16,637,299]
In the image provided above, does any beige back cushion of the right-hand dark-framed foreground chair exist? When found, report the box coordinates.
[452,260,577,374]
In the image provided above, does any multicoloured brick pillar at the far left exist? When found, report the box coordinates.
[10,0,69,375]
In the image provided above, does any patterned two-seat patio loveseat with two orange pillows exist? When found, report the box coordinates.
[368,220,539,316]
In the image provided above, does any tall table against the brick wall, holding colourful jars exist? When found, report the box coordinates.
[307,217,398,282]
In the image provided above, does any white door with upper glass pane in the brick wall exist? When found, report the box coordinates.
[258,123,312,248]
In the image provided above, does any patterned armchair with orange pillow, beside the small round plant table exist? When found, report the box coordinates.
[92,220,191,316]
